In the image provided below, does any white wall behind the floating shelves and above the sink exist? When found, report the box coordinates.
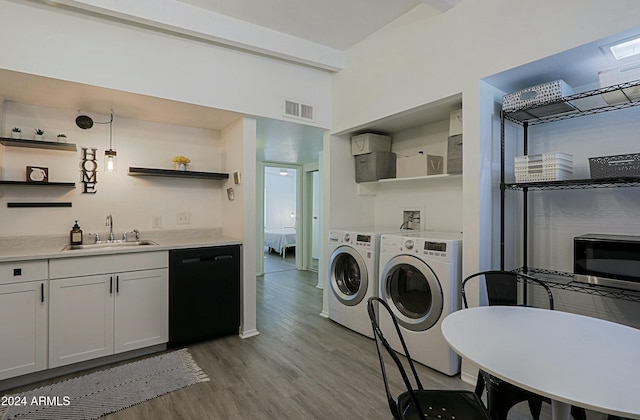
[0,101,227,236]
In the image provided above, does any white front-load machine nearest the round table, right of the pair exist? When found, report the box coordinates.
[379,232,462,376]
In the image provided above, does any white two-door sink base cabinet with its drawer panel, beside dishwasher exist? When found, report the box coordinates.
[49,252,169,368]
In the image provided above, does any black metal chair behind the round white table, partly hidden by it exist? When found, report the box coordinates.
[461,270,587,420]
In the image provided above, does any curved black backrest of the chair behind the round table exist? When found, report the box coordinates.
[461,270,553,309]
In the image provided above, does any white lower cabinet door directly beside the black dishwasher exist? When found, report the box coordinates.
[115,268,169,353]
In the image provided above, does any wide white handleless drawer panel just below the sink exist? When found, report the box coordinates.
[49,251,169,279]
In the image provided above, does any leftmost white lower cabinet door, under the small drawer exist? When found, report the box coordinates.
[0,280,48,380]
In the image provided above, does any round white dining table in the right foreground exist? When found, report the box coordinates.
[442,306,640,420]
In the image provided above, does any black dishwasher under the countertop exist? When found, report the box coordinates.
[169,245,240,347]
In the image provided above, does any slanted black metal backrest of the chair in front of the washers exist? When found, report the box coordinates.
[367,296,424,419]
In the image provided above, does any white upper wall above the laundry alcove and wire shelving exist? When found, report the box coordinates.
[332,0,640,135]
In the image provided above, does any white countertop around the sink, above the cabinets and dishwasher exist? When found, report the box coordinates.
[0,229,242,262]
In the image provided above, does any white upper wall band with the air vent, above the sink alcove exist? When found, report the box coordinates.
[0,0,331,128]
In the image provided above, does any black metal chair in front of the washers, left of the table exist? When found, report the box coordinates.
[367,297,491,420]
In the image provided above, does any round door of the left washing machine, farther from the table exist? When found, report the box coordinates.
[329,245,369,306]
